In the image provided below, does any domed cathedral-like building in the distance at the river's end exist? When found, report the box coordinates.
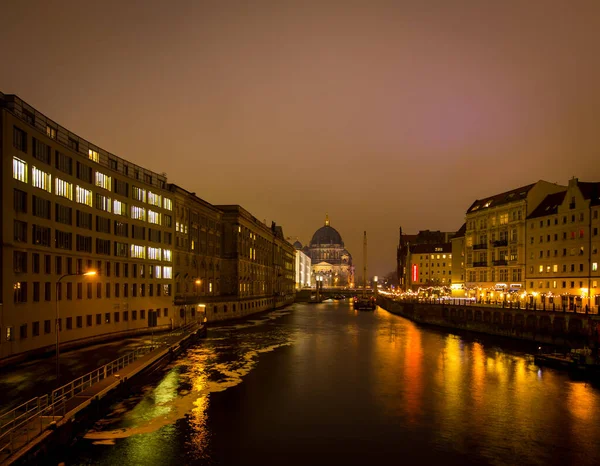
[302,215,354,288]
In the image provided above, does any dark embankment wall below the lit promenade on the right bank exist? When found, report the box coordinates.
[377,295,600,348]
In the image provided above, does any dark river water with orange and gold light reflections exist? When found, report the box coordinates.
[59,302,600,466]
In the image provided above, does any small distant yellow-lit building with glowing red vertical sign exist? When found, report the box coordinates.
[406,243,452,291]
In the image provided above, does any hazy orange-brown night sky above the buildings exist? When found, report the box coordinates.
[0,0,600,275]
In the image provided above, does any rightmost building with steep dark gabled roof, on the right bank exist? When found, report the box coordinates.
[527,178,600,309]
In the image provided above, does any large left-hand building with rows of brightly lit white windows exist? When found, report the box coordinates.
[0,93,177,358]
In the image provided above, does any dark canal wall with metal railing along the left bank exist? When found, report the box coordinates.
[2,325,206,465]
